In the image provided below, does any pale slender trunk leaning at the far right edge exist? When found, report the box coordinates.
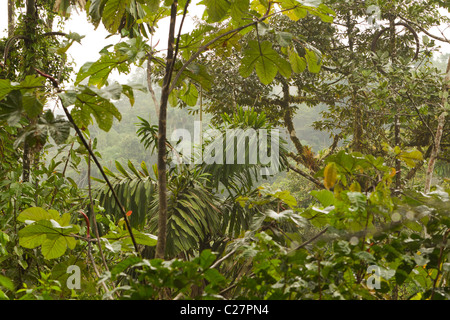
[424,58,450,193]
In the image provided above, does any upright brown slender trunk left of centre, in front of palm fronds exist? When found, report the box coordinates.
[155,1,178,259]
